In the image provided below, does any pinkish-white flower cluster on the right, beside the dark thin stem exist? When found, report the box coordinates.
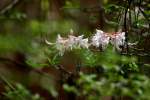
[92,30,125,50]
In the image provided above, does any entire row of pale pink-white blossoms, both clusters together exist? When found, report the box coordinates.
[46,30,125,55]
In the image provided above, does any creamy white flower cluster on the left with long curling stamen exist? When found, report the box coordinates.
[46,34,89,55]
